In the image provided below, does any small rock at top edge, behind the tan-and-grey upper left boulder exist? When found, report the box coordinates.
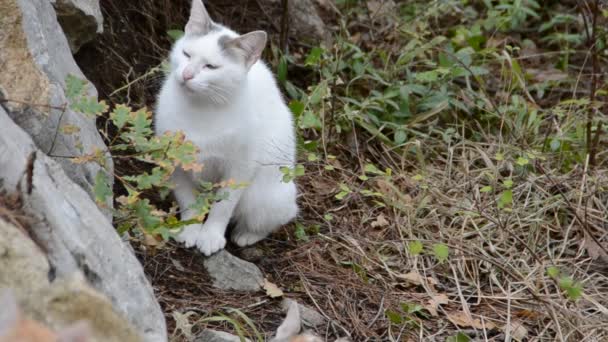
[51,0,103,53]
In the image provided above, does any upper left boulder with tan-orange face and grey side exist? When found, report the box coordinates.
[0,0,112,211]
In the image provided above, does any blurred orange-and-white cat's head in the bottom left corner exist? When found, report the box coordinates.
[0,290,91,342]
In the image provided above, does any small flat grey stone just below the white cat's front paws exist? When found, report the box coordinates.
[204,250,264,291]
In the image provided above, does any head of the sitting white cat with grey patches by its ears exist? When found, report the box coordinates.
[170,0,266,104]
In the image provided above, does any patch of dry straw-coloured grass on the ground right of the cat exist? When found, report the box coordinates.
[280,139,608,341]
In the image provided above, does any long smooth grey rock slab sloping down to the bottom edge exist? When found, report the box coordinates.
[0,107,167,342]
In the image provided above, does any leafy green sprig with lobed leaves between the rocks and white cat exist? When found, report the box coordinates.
[64,75,223,243]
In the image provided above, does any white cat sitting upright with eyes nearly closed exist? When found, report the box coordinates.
[155,0,298,255]
